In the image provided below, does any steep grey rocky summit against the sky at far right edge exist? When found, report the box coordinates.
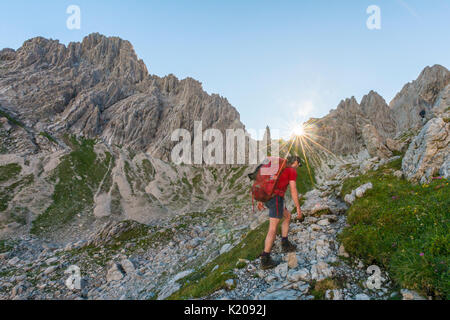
[390,65,450,133]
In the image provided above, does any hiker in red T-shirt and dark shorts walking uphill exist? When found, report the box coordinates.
[258,156,303,269]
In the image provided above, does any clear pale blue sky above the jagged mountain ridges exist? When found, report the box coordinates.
[0,0,450,138]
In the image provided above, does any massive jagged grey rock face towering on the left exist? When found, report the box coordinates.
[0,33,244,160]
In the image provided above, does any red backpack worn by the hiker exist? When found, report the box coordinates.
[252,157,287,203]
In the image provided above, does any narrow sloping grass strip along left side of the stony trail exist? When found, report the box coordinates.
[169,222,268,300]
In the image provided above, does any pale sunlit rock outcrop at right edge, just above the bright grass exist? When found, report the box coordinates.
[402,118,450,183]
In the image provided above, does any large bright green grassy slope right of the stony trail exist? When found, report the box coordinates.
[340,160,450,299]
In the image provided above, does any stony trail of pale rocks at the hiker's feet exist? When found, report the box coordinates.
[208,208,397,300]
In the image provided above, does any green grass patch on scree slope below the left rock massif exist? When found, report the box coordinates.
[31,137,112,234]
